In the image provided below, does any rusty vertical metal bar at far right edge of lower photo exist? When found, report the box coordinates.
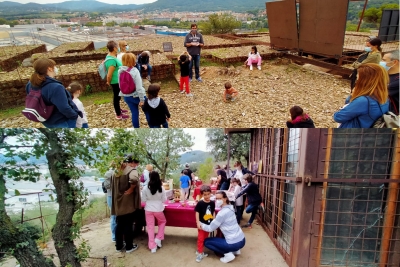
[379,132,400,267]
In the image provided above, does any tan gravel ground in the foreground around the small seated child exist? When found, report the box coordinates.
[0,60,350,128]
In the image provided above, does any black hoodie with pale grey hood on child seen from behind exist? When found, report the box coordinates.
[142,97,171,126]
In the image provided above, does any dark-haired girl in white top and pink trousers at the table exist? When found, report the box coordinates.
[142,171,167,253]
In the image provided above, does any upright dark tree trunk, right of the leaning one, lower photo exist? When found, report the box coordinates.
[40,129,81,267]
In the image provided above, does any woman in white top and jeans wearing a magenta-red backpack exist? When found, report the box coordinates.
[118,53,149,128]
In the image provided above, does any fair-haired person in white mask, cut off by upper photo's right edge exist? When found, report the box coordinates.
[380,50,399,115]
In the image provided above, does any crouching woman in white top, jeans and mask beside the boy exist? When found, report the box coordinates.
[198,191,246,263]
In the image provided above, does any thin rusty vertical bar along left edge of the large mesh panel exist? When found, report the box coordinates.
[315,128,333,266]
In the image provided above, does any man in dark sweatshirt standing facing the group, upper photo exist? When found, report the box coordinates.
[183,23,204,82]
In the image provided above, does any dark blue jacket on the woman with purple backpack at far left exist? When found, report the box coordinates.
[25,76,80,127]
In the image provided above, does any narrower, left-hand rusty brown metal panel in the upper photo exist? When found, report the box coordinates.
[266,0,298,50]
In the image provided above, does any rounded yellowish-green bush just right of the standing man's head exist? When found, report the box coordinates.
[199,13,242,34]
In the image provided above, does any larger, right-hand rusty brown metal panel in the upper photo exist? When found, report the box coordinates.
[299,0,349,57]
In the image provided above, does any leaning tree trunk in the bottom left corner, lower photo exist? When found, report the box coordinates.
[0,175,55,267]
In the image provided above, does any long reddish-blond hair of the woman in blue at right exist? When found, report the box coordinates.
[350,63,389,104]
